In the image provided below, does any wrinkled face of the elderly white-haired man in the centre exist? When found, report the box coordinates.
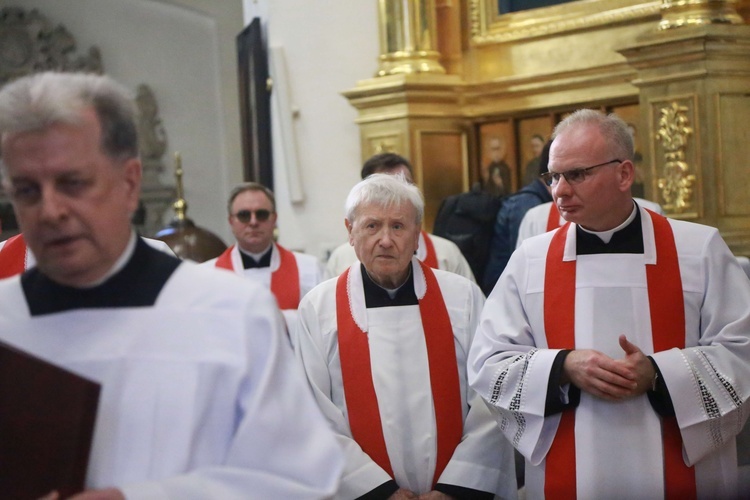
[346,202,420,288]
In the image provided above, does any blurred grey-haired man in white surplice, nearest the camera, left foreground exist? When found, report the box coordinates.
[0,73,343,500]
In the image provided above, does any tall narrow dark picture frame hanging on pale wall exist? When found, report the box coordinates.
[237,17,273,189]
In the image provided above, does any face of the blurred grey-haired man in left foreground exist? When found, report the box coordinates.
[2,110,141,286]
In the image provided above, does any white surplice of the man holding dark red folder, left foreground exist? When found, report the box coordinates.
[0,251,342,500]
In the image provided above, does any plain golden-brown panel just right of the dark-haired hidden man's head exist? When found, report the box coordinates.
[419,132,466,230]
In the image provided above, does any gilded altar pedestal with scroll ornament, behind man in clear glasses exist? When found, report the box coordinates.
[619,0,750,256]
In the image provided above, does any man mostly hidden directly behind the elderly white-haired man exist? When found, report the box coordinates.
[324,153,475,281]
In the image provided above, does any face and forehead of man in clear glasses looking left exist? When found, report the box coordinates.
[549,125,633,231]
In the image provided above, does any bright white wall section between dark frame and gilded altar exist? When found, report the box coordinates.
[244,0,379,259]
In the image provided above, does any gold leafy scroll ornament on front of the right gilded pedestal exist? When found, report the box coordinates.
[656,102,695,213]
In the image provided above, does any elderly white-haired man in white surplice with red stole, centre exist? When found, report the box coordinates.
[293,174,517,499]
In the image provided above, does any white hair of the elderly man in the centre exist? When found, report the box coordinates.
[344,173,424,226]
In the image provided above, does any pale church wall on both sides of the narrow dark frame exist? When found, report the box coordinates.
[0,0,378,258]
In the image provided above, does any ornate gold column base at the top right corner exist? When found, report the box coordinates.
[659,0,744,30]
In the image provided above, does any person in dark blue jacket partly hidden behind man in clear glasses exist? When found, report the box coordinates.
[482,139,552,295]
